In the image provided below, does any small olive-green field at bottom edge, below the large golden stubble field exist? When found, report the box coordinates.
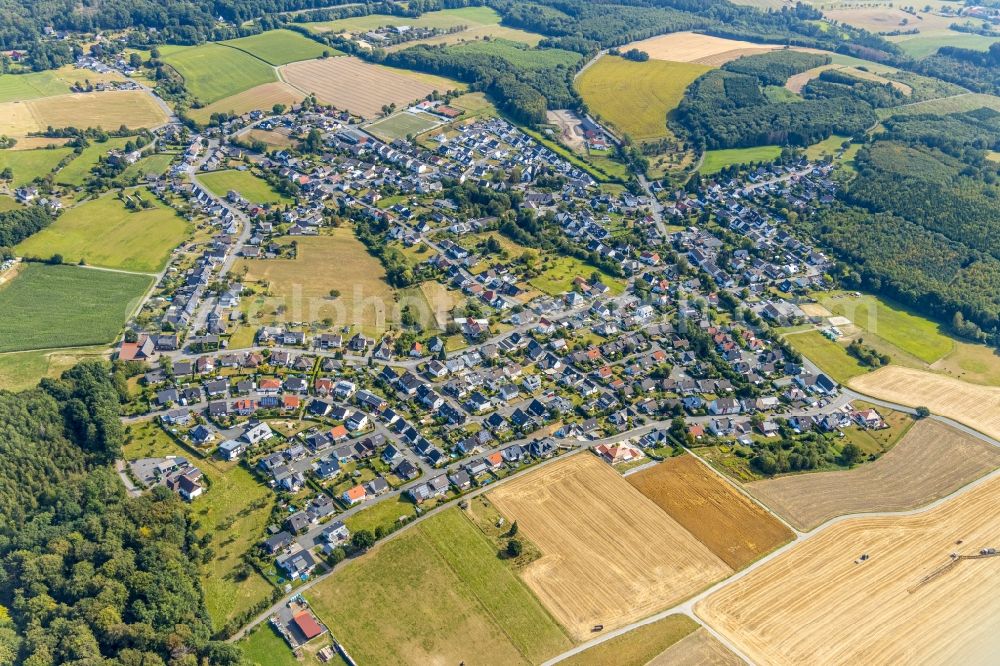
[559,615,698,666]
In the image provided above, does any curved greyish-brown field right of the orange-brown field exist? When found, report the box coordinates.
[746,419,1000,530]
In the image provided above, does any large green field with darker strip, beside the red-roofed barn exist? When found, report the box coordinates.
[306,509,571,664]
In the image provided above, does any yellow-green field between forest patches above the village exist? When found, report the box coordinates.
[576,56,711,142]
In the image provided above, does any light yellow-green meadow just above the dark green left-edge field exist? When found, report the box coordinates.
[16,188,191,273]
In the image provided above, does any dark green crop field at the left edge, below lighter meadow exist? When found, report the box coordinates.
[0,264,152,352]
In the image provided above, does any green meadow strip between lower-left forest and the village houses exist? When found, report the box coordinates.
[125,421,274,631]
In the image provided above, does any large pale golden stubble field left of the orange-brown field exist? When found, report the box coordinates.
[489,454,732,640]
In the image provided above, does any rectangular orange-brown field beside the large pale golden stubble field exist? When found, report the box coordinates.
[626,455,795,570]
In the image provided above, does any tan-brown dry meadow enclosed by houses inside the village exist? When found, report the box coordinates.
[236,227,399,335]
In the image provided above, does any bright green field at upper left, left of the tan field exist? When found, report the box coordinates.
[163,44,278,104]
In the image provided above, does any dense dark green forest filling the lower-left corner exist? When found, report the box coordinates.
[0,362,241,666]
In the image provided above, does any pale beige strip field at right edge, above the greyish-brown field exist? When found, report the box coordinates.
[848,365,1000,439]
